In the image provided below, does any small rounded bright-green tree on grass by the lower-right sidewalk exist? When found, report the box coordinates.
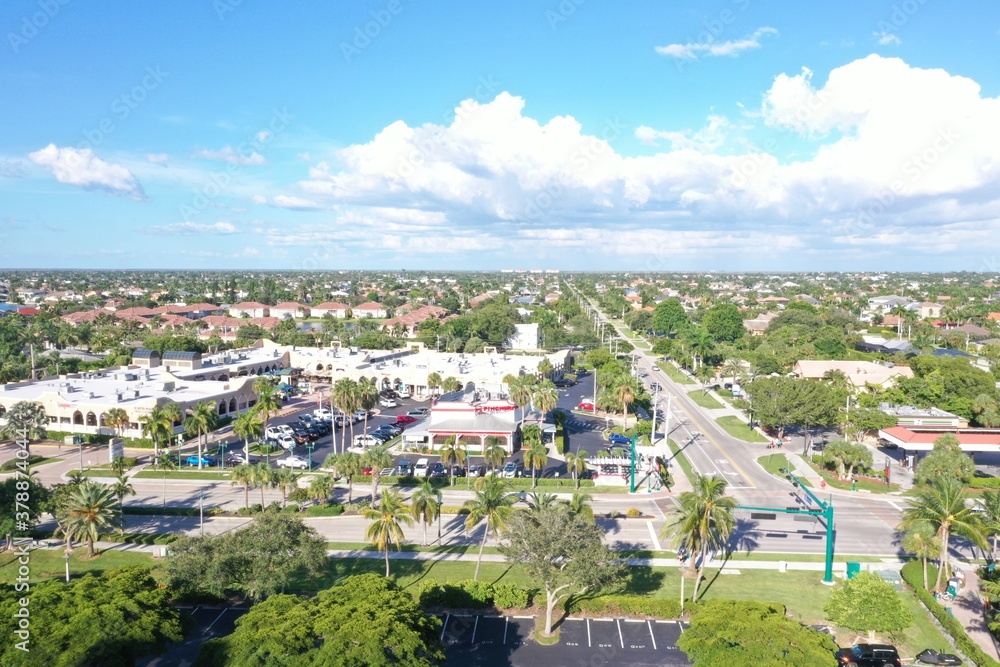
[824,572,913,640]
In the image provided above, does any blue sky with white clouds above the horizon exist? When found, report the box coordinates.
[0,0,1000,272]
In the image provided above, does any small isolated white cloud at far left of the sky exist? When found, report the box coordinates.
[28,144,146,201]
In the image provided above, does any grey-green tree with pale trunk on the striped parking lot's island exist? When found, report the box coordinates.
[500,504,627,637]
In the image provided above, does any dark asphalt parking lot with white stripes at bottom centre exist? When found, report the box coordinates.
[441,615,691,667]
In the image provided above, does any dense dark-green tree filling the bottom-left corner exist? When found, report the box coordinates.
[0,567,184,667]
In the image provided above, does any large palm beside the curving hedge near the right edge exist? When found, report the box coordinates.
[899,477,986,590]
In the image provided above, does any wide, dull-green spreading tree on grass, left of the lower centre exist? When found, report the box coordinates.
[166,512,326,602]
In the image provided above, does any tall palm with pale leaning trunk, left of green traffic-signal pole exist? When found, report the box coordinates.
[663,475,738,602]
